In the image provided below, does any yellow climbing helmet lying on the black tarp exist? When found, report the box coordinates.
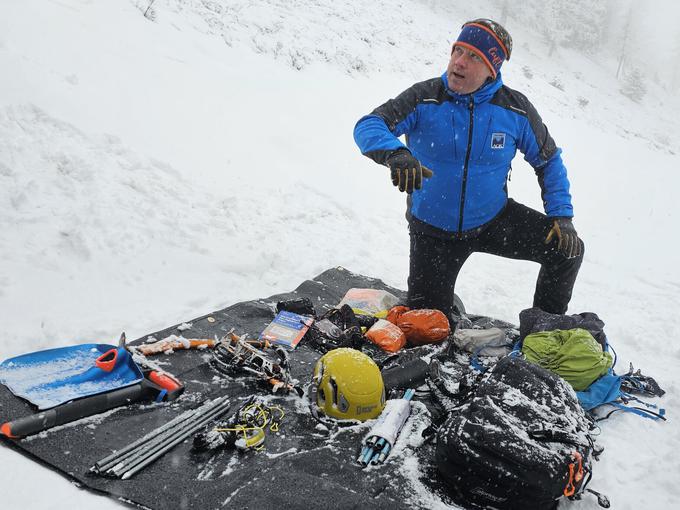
[311,347,385,421]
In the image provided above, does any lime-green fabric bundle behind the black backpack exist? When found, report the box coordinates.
[522,328,613,391]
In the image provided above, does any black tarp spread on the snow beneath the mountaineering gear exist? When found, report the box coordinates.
[0,268,460,510]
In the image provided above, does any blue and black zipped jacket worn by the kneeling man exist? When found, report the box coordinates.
[354,73,573,237]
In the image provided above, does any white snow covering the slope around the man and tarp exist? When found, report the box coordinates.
[0,0,680,509]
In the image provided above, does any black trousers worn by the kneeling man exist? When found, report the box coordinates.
[408,200,583,317]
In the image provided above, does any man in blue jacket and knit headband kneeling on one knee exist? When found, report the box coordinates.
[354,19,584,317]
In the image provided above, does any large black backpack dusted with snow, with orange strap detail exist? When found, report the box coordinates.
[435,356,608,510]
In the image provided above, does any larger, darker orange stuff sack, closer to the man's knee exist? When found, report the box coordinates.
[387,306,451,345]
